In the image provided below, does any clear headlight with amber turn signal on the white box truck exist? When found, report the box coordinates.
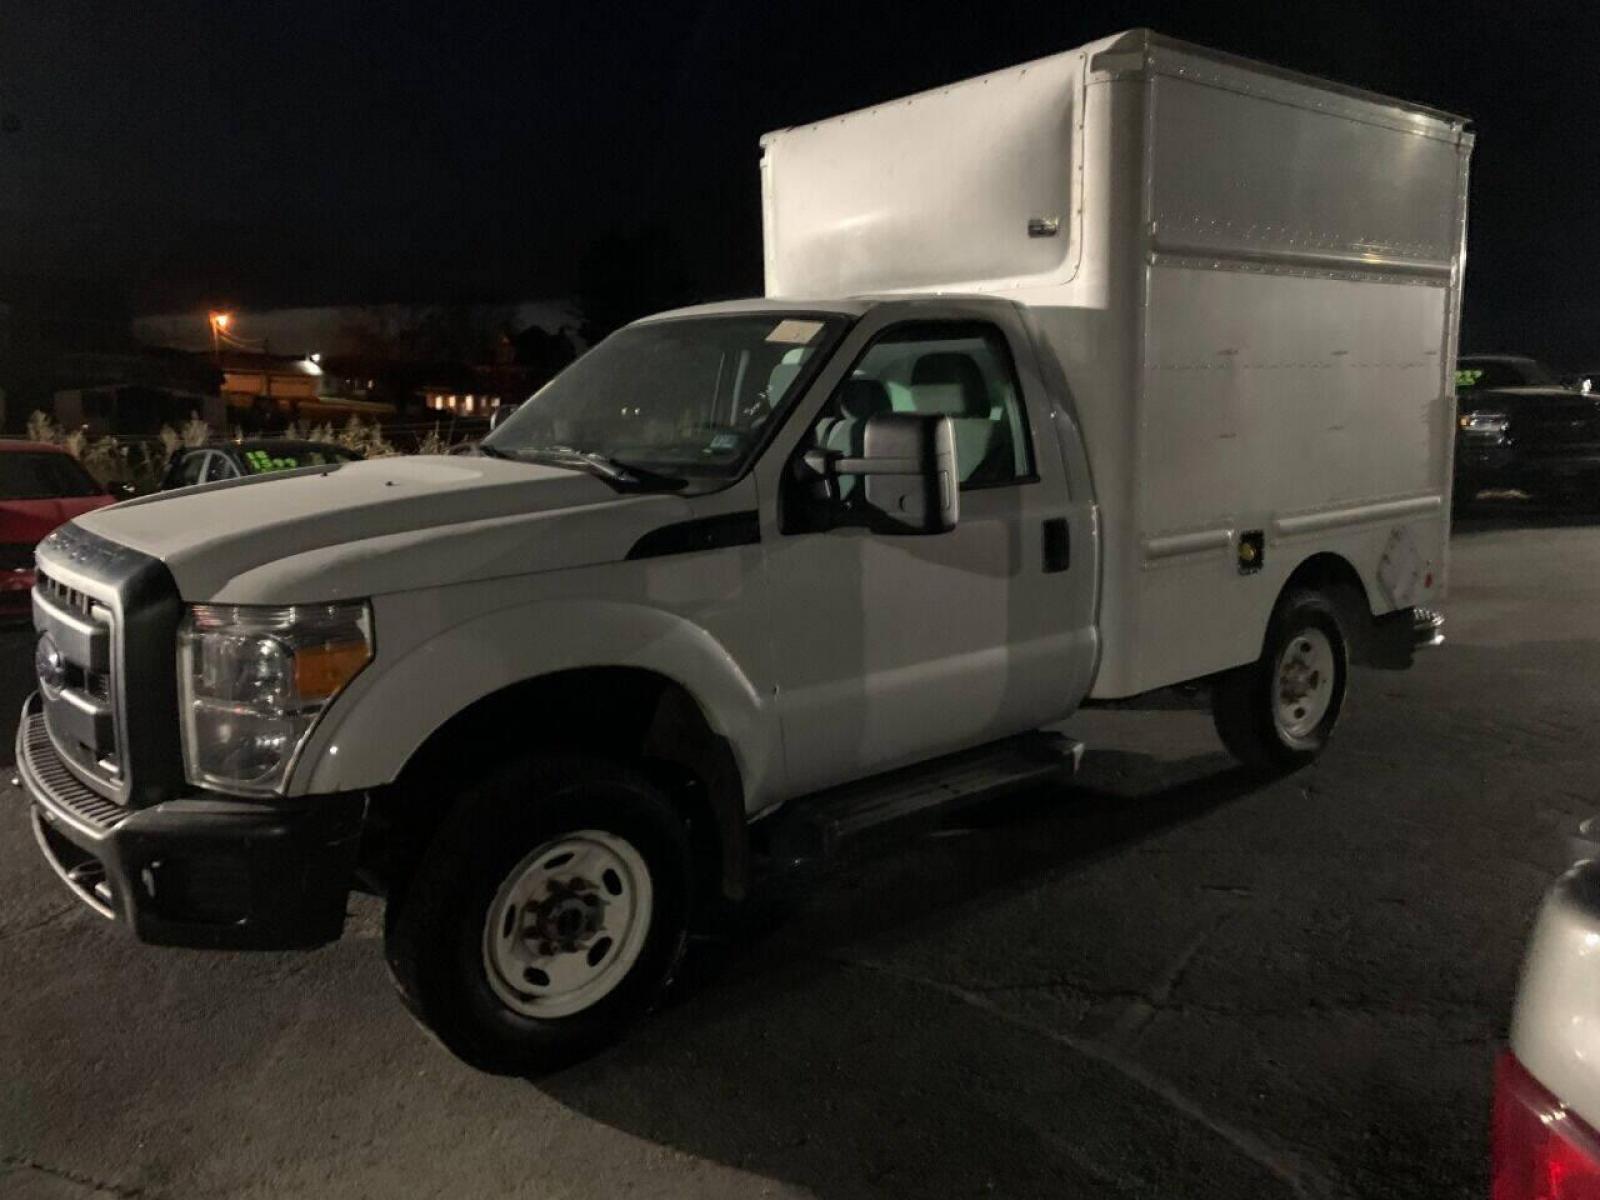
[178,602,373,794]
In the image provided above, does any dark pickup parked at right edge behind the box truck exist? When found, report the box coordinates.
[1454,387,1600,509]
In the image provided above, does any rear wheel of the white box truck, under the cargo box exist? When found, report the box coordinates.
[1211,590,1350,774]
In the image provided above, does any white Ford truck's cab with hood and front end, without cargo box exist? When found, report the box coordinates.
[19,298,1098,1059]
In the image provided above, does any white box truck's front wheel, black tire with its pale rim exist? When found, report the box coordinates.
[384,755,691,1075]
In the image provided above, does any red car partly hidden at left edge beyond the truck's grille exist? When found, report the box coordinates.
[0,440,118,618]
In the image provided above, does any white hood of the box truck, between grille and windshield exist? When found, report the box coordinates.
[78,458,688,603]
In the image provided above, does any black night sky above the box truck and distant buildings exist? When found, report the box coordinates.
[0,0,1600,366]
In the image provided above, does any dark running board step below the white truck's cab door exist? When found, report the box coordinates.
[768,733,1083,866]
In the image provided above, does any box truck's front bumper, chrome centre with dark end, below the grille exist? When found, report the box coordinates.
[16,694,366,949]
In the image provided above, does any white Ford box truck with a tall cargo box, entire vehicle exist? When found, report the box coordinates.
[18,32,1472,1070]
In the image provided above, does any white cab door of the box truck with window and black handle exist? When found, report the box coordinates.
[758,301,1094,795]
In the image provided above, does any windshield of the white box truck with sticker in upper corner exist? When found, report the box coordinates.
[483,312,848,482]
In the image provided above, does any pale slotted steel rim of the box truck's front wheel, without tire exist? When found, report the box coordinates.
[483,829,653,1019]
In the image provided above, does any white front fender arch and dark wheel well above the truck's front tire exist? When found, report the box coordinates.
[294,595,781,893]
